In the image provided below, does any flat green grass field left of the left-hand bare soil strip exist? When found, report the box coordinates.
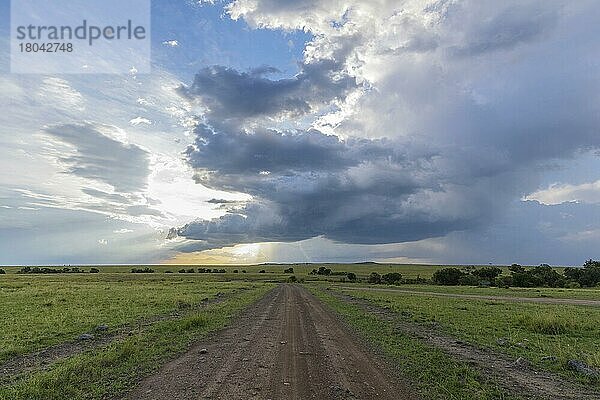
[0,274,262,363]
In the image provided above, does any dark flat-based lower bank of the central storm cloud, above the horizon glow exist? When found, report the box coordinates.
[179,121,502,249]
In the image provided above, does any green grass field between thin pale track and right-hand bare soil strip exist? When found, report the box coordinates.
[334,282,600,387]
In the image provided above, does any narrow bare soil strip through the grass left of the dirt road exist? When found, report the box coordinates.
[0,289,245,384]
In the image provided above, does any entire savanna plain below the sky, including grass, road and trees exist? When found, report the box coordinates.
[0,260,600,400]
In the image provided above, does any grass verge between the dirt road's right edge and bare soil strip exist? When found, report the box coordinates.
[307,285,521,400]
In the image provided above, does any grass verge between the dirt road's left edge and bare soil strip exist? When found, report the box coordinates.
[0,285,272,400]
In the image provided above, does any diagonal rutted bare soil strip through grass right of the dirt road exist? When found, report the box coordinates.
[328,291,600,400]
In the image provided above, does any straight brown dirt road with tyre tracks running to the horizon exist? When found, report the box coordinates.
[126,285,417,400]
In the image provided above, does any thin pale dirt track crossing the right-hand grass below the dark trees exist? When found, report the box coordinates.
[338,286,600,307]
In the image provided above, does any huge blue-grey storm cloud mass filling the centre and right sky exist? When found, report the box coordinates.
[173,1,600,256]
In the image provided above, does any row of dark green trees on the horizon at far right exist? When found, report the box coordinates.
[432,260,600,288]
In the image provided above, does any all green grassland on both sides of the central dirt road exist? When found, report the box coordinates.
[0,263,600,400]
